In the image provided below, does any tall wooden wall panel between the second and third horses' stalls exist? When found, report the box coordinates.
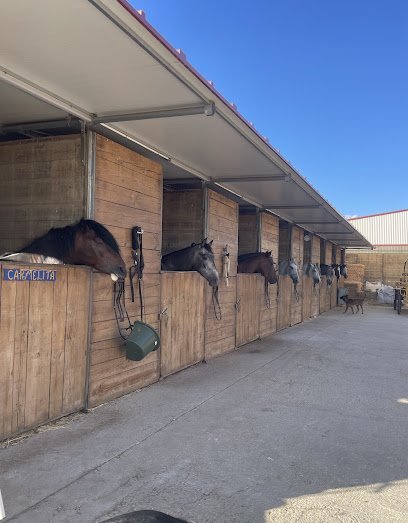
[205,190,238,358]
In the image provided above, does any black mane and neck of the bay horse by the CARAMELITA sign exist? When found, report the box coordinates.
[20,219,119,261]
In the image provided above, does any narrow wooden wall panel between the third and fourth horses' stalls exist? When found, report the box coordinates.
[258,212,279,338]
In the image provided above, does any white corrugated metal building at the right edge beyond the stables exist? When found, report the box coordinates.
[349,209,408,252]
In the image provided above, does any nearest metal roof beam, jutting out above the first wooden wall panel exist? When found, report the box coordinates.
[92,103,215,124]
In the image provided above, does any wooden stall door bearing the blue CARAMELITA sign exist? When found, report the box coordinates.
[0,263,90,439]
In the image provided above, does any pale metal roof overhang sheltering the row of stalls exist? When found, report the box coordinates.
[0,0,371,247]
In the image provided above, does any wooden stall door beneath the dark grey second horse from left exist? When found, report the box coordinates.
[160,272,204,376]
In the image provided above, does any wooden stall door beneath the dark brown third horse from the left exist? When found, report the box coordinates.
[236,274,263,347]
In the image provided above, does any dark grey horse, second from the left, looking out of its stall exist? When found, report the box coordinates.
[161,238,220,287]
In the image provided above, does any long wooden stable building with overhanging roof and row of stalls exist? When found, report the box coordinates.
[0,0,371,438]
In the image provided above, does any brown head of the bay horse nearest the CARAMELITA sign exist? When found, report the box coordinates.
[71,220,126,281]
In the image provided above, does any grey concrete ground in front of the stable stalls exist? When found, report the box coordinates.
[0,306,408,523]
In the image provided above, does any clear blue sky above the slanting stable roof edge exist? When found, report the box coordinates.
[131,0,408,216]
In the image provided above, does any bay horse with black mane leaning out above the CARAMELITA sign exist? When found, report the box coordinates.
[1,219,126,281]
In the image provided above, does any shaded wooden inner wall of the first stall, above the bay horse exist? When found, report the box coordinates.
[0,135,85,253]
